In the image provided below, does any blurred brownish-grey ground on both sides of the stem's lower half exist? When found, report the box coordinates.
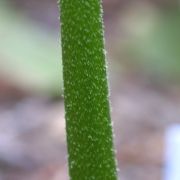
[0,74,180,180]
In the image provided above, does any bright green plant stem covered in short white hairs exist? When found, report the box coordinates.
[59,0,117,180]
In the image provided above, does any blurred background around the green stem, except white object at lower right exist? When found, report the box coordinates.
[0,0,180,180]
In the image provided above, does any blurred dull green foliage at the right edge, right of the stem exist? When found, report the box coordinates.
[129,9,180,82]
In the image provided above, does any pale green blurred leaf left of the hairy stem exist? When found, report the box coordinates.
[0,1,62,96]
